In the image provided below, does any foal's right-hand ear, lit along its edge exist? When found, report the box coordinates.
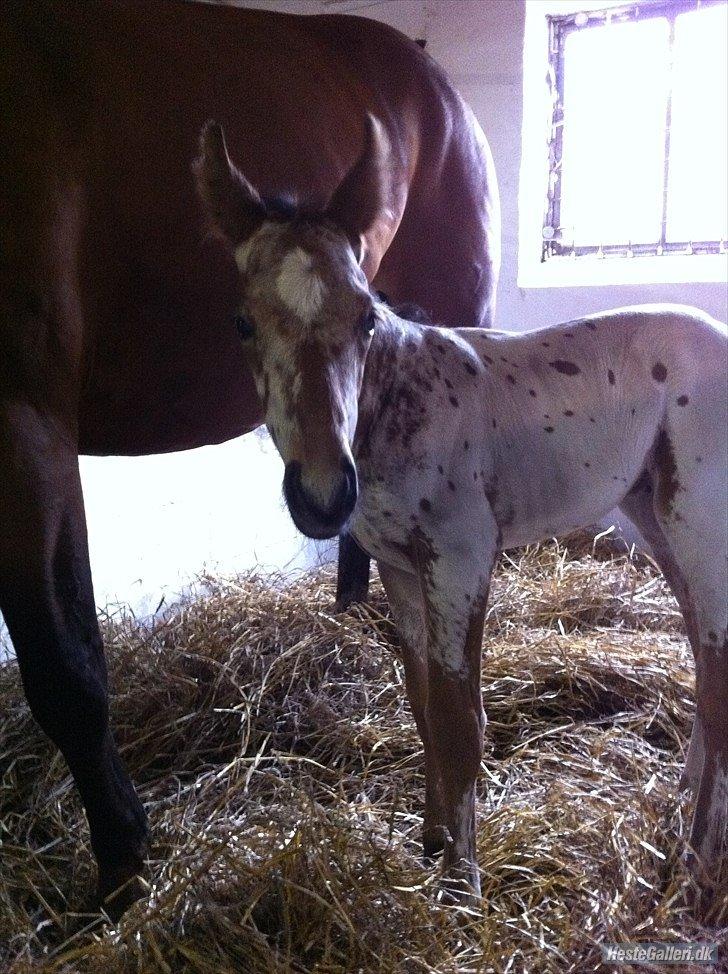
[325,112,391,255]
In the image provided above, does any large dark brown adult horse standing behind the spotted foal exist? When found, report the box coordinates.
[0,0,499,916]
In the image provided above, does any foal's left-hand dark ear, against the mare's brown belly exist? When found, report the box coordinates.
[192,122,265,246]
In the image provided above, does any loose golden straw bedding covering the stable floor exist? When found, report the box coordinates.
[0,539,728,974]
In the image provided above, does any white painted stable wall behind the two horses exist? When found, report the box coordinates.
[2,0,728,656]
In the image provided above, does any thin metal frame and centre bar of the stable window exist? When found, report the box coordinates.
[540,0,728,265]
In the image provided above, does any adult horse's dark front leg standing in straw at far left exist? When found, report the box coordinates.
[0,400,147,912]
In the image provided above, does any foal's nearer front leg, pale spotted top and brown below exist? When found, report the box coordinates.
[417,529,496,902]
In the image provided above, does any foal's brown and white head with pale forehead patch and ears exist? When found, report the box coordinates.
[194,116,387,538]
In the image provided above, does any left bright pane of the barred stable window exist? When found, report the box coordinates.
[561,17,669,246]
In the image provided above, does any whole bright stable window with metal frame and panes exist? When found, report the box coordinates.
[541,0,728,261]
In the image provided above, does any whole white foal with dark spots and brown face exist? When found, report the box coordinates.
[196,122,728,898]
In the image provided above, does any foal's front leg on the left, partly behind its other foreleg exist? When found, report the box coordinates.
[379,562,445,858]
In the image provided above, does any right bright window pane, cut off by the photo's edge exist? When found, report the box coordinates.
[667,5,728,248]
